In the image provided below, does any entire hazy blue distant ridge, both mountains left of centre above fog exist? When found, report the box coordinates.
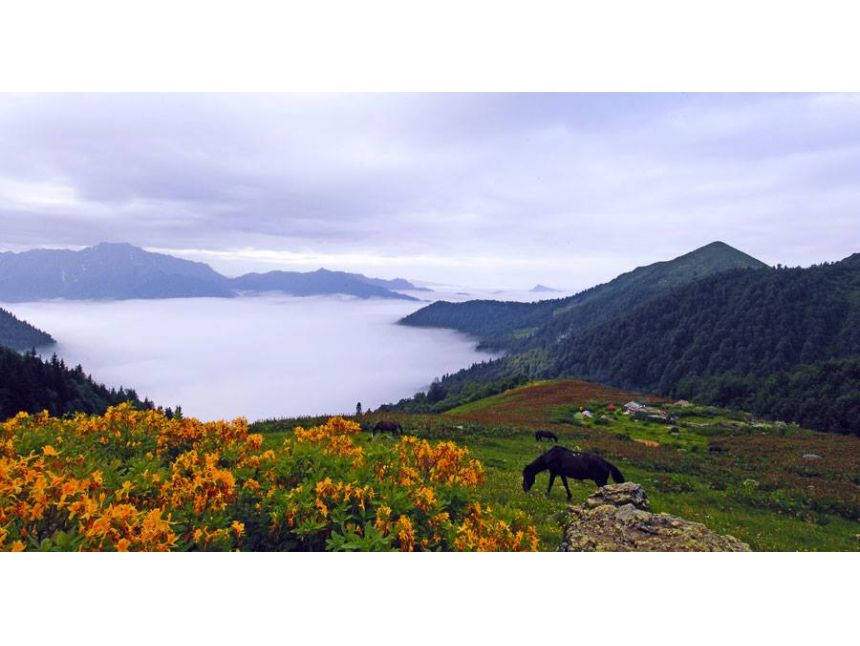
[0,243,417,302]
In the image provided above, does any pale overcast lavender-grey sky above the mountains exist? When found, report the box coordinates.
[0,94,860,289]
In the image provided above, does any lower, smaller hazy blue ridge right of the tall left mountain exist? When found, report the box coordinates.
[229,269,418,301]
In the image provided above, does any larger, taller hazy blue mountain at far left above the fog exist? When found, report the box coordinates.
[0,243,233,302]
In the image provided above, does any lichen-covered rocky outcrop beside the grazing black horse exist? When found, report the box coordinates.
[559,482,750,552]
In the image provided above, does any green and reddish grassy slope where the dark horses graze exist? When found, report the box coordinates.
[256,380,860,551]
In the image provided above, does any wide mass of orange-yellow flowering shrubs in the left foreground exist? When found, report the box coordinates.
[0,404,537,551]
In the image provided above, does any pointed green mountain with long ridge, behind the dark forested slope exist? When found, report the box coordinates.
[401,242,767,351]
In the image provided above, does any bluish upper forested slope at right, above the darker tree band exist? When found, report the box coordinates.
[545,254,860,390]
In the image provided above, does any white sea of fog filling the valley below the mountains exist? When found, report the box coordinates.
[0,293,498,420]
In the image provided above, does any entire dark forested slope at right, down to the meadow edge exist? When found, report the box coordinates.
[544,254,860,432]
